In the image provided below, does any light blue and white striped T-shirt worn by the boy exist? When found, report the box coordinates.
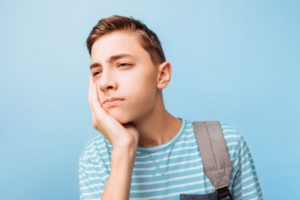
[79,118,263,200]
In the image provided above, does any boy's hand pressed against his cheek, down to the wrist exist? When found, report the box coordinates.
[88,75,139,148]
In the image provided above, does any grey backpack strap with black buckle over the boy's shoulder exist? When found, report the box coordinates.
[192,121,232,200]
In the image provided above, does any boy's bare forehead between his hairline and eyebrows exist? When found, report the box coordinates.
[91,31,148,62]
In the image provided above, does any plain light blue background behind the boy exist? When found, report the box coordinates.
[0,0,300,200]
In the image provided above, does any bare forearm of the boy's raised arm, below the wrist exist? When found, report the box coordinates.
[102,148,136,200]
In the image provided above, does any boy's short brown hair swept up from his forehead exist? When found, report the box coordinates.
[86,15,166,64]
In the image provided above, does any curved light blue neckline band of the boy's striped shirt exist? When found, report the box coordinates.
[137,117,186,152]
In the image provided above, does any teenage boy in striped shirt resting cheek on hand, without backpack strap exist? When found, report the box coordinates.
[79,15,262,200]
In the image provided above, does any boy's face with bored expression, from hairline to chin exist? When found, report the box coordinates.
[91,31,162,124]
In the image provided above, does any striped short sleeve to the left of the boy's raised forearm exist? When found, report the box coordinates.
[79,138,109,200]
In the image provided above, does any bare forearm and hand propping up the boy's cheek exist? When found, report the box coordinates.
[83,76,139,200]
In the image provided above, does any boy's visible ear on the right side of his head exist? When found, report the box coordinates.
[157,61,172,89]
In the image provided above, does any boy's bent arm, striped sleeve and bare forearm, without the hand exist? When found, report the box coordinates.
[79,141,136,200]
